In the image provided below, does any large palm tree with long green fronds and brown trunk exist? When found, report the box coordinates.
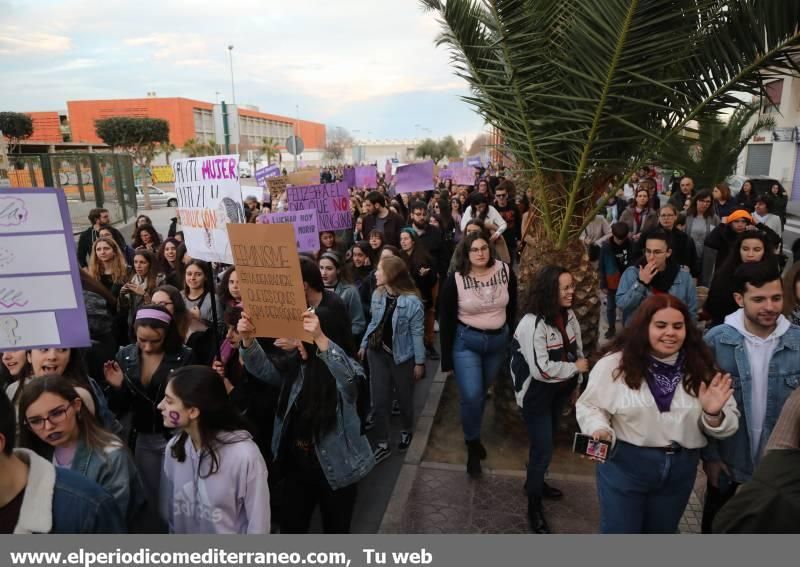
[421,0,800,346]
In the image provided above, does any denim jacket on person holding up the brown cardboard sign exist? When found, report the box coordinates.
[240,341,375,490]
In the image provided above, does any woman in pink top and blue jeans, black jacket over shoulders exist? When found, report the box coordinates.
[439,233,517,476]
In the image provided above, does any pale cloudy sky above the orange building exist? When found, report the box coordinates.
[0,0,484,144]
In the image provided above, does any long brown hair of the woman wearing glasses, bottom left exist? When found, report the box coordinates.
[18,374,124,459]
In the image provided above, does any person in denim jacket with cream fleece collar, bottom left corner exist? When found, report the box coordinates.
[0,396,125,534]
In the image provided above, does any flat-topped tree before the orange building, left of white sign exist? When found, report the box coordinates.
[95,116,169,210]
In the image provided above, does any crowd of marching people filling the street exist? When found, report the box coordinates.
[0,166,800,534]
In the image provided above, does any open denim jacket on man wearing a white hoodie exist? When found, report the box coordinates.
[703,325,800,483]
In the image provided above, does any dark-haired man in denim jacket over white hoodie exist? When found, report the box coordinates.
[702,262,800,533]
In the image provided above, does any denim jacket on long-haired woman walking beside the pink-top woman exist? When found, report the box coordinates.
[361,290,425,364]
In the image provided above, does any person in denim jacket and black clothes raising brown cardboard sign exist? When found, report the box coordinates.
[237,309,375,533]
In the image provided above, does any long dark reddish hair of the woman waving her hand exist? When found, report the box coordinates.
[601,294,719,397]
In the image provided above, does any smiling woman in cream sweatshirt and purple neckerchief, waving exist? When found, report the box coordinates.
[576,294,739,533]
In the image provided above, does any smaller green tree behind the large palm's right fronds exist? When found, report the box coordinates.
[658,106,775,193]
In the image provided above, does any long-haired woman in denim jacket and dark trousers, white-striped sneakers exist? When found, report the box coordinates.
[358,256,425,463]
